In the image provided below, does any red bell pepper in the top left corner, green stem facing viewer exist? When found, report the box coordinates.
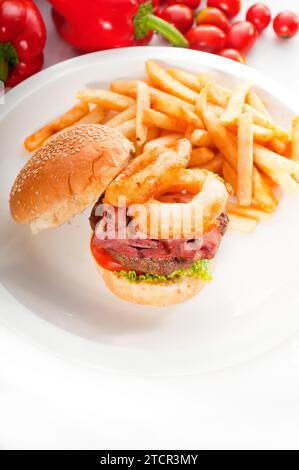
[0,0,46,88]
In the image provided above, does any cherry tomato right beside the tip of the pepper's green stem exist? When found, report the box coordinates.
[186,24,226,53]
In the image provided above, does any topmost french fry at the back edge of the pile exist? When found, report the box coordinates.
[146,60,197,103]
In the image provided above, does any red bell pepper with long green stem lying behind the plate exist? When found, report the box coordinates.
[49,0,188,52]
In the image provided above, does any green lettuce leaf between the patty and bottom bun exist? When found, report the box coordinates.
[115,259,213,283]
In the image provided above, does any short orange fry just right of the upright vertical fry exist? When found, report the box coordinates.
[252,166,278,212]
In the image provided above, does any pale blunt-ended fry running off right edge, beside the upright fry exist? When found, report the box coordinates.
[253,144,299,181]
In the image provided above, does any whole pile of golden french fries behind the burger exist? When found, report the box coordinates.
[24,60,299,232]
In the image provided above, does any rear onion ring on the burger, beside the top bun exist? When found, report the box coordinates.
[104,139,191,206]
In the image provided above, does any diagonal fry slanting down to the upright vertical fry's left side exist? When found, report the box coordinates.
[203,106,238,168]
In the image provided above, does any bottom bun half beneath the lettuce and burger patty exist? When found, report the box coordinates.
[97,260,213,307]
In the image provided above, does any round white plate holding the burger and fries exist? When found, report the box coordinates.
[0,47,299,374]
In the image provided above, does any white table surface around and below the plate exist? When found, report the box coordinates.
[0,0,299,449]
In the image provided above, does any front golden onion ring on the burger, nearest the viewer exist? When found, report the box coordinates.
[128,169,228,239]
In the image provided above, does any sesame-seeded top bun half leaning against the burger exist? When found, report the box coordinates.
[10,124,134,233]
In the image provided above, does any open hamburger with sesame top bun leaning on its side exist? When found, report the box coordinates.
[9,125,228,306]
